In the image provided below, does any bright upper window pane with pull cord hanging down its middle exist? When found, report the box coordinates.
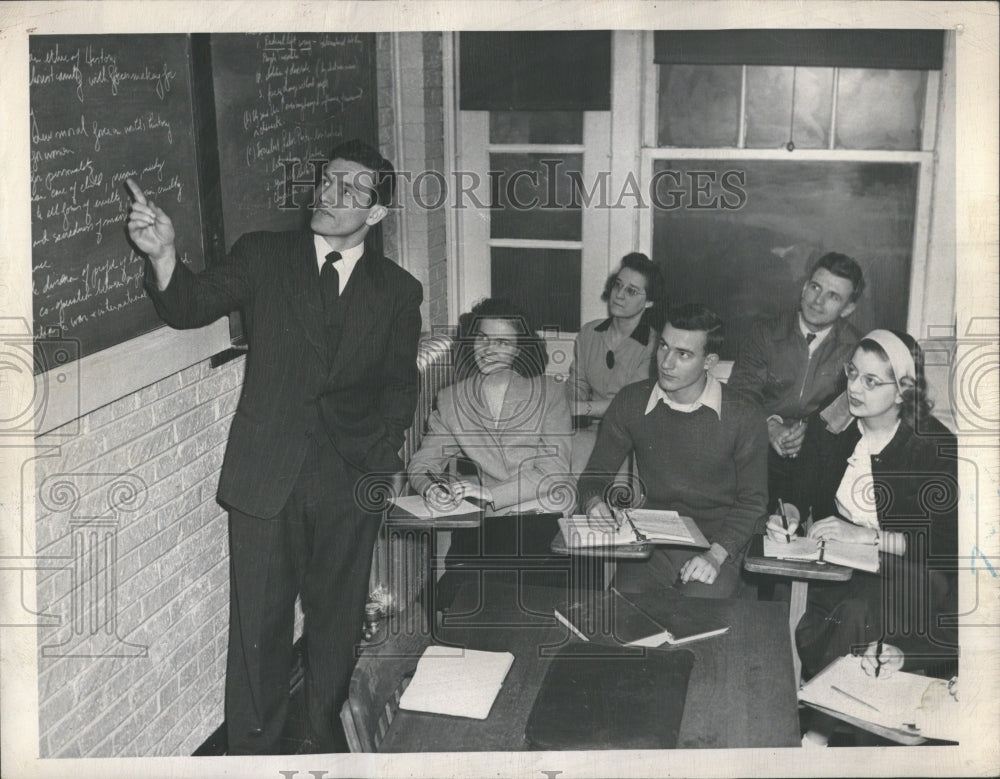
[746,67,833,149]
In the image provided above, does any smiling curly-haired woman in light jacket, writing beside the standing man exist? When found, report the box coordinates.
[407,298,575,607]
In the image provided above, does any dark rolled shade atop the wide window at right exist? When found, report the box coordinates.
[653,30,944,70]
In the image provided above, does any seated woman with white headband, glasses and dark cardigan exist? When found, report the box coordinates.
[767,330,958,743]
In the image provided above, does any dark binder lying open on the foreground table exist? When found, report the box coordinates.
[555,588,729,648]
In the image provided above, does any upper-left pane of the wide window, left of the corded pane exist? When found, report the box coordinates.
[657,65,742,147]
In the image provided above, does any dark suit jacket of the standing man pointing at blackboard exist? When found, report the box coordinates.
[146,231,423,517]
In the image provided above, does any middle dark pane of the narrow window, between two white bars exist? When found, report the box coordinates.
[490,153,585,241]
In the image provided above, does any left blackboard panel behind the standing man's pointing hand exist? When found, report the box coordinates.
[28,35,205,373]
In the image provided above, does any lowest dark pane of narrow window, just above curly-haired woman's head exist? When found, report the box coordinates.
[490,247,581,333]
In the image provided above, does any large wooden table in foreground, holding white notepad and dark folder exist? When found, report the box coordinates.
[351,574,800,752]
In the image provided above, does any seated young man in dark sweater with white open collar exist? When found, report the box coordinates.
[579,305,768,598]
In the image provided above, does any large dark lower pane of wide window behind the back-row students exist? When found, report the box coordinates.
[651,164,919,360]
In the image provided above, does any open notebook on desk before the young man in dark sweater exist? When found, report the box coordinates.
[559,509,709,549]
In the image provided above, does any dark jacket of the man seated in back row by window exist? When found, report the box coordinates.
[727,309,861,422]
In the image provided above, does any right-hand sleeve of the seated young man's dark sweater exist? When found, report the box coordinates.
[708,404,768,560]
